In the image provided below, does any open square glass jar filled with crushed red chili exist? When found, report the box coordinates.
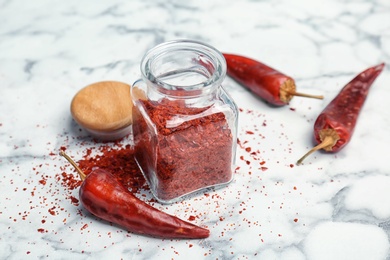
[131,40,238,203]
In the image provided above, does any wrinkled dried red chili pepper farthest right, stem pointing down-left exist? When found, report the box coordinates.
[297,63,385,164]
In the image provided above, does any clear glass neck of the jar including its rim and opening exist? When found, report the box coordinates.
[141,40,226,100]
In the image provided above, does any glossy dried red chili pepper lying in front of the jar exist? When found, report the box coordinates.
[60,151,210,238]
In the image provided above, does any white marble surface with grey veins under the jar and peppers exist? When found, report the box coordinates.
[0,0,390,259]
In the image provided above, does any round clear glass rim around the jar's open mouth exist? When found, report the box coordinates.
[140,40,226,97]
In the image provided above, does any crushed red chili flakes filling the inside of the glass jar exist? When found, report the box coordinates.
[133,100,236,202]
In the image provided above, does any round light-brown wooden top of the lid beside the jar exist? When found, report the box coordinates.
[70,81,133,132]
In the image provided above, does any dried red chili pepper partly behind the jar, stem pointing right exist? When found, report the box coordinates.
[223,53,323,106]
